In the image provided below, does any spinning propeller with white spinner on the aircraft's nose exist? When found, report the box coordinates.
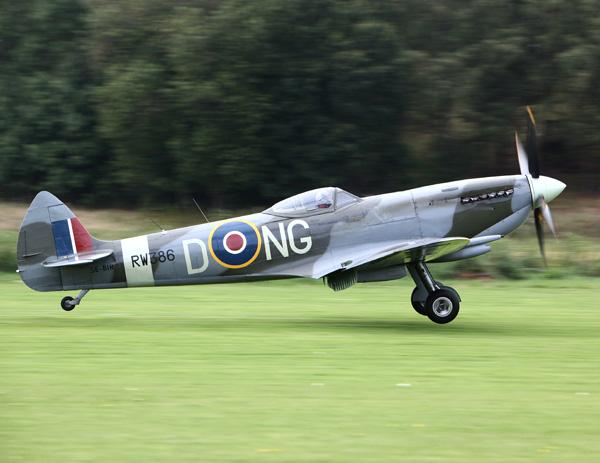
[515,106,566,266]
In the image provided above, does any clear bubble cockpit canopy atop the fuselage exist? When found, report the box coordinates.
[265,187,360,217]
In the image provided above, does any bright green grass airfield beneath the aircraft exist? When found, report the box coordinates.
[0,274,600,463]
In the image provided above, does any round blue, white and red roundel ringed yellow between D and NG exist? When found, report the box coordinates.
[208,220,262,268]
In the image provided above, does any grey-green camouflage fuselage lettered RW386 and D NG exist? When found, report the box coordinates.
[17,175,533,291]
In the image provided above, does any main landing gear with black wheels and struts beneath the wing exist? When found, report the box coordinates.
[406,262,460,324]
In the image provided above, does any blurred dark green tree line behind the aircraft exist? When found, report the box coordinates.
[0,0,600,207]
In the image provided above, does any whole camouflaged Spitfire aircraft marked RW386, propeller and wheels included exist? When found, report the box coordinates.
[17,111,565,324]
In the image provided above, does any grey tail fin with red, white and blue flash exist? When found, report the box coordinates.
[17,191,101,291]
